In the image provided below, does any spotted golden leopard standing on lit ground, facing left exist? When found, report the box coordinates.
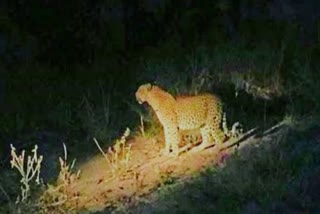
[135,83,225,155]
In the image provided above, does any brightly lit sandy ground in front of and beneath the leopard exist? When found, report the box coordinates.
[61,122,286,211]
